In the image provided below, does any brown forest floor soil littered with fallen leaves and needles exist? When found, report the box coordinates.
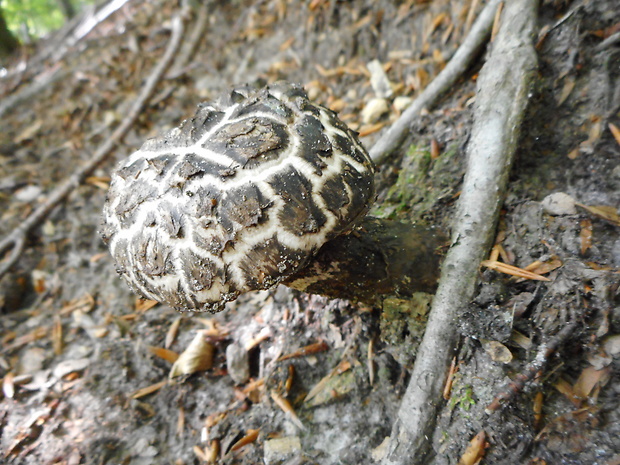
[0,0,620,465]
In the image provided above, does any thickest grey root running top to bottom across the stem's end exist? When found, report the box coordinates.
[382,0,537,465]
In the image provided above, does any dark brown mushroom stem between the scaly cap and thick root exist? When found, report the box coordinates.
[283,217,448,304]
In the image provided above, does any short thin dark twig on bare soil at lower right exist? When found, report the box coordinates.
[484,320,577,414]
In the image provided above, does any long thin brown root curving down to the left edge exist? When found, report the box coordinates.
[0,16,183,278]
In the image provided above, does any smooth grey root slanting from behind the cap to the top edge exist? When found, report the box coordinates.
[370,0,500,163]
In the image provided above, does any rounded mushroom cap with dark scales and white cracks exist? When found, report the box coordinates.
[102,83,374,311]
